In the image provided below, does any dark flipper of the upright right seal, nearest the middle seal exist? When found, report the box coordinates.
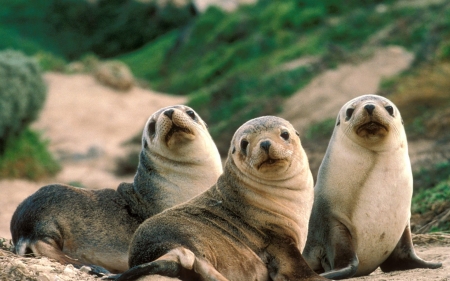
[320,222,359,280]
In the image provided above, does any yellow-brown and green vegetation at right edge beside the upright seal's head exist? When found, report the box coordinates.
[382,62,450,139]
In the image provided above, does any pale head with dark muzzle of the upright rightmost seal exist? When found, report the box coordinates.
[336,95,404,148]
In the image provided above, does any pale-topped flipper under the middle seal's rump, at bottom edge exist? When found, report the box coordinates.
[115,247,228,281]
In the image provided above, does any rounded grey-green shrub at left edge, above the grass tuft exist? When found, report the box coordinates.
[0,51,47,151]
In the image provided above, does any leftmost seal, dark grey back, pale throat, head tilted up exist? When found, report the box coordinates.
[11,105,223,273]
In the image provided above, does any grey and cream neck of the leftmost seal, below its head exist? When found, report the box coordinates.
[121,150,222,219]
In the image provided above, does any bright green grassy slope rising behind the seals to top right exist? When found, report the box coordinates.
[119,0,450,155]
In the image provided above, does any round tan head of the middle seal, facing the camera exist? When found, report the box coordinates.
[229,116,307,179]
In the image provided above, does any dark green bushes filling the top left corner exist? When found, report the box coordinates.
[0,0,194,59]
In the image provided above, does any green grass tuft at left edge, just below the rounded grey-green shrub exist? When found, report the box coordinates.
[0,129,60,180]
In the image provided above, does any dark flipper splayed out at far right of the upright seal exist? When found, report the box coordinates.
[380,224,442,272]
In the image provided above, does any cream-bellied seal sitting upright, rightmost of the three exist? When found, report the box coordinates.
[303,95,441,279]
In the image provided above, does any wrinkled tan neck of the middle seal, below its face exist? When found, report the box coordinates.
[217,159,313,250]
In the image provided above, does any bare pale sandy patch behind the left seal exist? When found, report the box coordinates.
[0,73,186,238]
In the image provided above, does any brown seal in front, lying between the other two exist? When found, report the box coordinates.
[115,116,327,281]
